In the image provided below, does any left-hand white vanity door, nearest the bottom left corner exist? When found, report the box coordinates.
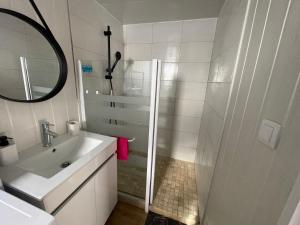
[55,178,97,225]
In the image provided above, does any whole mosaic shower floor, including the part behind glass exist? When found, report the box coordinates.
[118,156,199,225]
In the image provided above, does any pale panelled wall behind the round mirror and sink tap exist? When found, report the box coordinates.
[0,0,78,151]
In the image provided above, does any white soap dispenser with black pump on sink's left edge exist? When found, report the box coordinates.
[0,135,19,166]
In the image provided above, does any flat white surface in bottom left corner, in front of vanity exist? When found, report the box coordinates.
[0,190,55,225]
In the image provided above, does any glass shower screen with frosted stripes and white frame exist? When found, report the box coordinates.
[77,59,161,211]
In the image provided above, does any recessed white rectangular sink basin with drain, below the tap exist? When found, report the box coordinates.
[16,136,103,178]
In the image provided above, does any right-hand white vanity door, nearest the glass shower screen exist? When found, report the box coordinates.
[95,155,118,225]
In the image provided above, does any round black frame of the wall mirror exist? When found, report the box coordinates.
[0,8,68,103]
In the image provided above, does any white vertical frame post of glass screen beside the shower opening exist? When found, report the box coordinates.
[145,59,161,213]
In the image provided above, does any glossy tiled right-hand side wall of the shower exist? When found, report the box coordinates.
[196,0,247,217]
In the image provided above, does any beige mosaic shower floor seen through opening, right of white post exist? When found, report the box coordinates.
[150,157,199,225]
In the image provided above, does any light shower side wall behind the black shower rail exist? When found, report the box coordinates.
[68,0,125,143]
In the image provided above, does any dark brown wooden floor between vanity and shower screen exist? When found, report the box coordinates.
[105,202,147,225]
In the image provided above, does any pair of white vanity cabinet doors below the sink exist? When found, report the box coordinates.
[55,155,118,225]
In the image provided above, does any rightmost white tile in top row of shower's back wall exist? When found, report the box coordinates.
[182,18,217,42]
